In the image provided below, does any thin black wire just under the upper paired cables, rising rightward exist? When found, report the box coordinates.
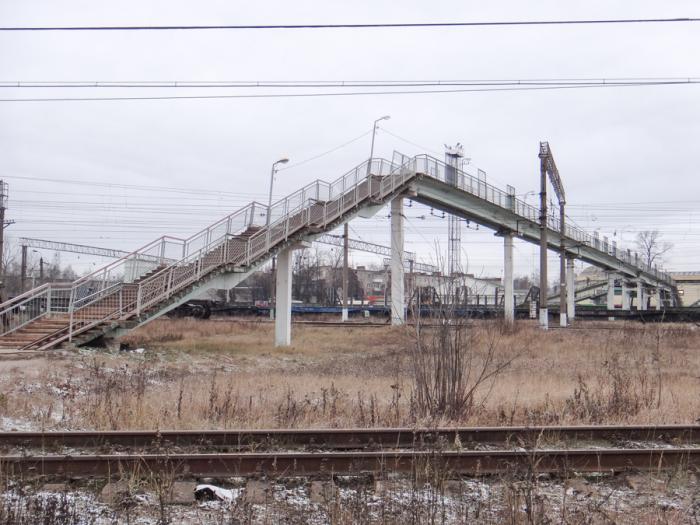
[0,79,700,102]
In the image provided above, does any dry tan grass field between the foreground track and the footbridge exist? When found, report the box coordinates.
[0,320,700,429]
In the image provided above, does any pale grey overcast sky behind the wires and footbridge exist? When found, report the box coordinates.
[0,0,700,282]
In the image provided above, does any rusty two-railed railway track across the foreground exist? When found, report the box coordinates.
[0,425,700,479]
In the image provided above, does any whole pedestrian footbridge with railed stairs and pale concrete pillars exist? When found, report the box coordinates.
[0,153,675,349]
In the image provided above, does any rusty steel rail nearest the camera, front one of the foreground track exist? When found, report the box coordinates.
[0,448,700,478]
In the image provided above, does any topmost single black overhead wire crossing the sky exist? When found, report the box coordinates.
[0,17,700,31]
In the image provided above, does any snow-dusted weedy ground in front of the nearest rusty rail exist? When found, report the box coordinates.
[2,475,700,525]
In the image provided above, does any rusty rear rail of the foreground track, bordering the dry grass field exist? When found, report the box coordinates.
[0,425,700,450]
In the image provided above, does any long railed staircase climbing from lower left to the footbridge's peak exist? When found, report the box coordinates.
[0,159,404,350]
